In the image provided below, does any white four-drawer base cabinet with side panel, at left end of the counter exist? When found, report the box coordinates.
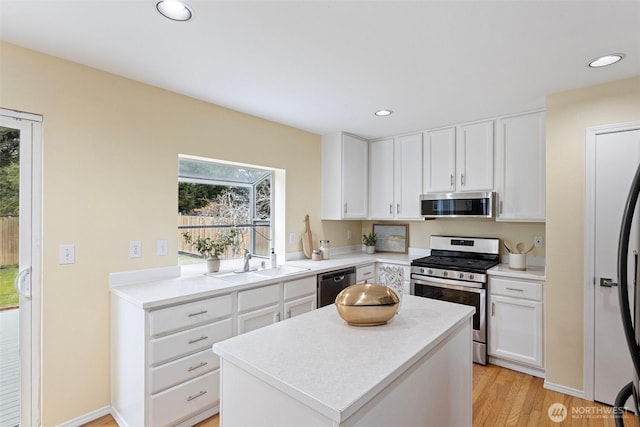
[111,294,234,427]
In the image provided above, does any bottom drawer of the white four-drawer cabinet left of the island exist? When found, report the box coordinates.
[149,370,220,426]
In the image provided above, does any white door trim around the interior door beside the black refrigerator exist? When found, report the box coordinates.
[583,122,640,401]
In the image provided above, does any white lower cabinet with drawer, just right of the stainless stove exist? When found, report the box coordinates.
[488,276,544,376]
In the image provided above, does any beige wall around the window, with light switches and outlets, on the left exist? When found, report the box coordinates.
[0,43,342,426]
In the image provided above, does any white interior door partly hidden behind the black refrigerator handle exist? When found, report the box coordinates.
[584,123,640,410]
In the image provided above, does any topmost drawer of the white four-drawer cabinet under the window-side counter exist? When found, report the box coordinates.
[149,295,233,336]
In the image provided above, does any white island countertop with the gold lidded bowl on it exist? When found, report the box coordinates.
[213,295,475,423]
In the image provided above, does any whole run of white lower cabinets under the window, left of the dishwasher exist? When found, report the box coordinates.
[111,275,317,427]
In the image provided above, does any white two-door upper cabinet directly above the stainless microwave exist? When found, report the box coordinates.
[423,121,493,193]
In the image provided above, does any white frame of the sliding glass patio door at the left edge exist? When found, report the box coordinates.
[0,108,42,425]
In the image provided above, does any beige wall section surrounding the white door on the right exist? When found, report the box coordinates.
[545,77,640,390]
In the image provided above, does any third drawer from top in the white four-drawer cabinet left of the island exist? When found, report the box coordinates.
[149,348,220,394]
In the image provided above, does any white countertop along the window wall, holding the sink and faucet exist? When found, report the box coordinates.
[111,252,418,310]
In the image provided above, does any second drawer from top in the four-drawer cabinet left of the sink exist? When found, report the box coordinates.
[149,319,233,365]
